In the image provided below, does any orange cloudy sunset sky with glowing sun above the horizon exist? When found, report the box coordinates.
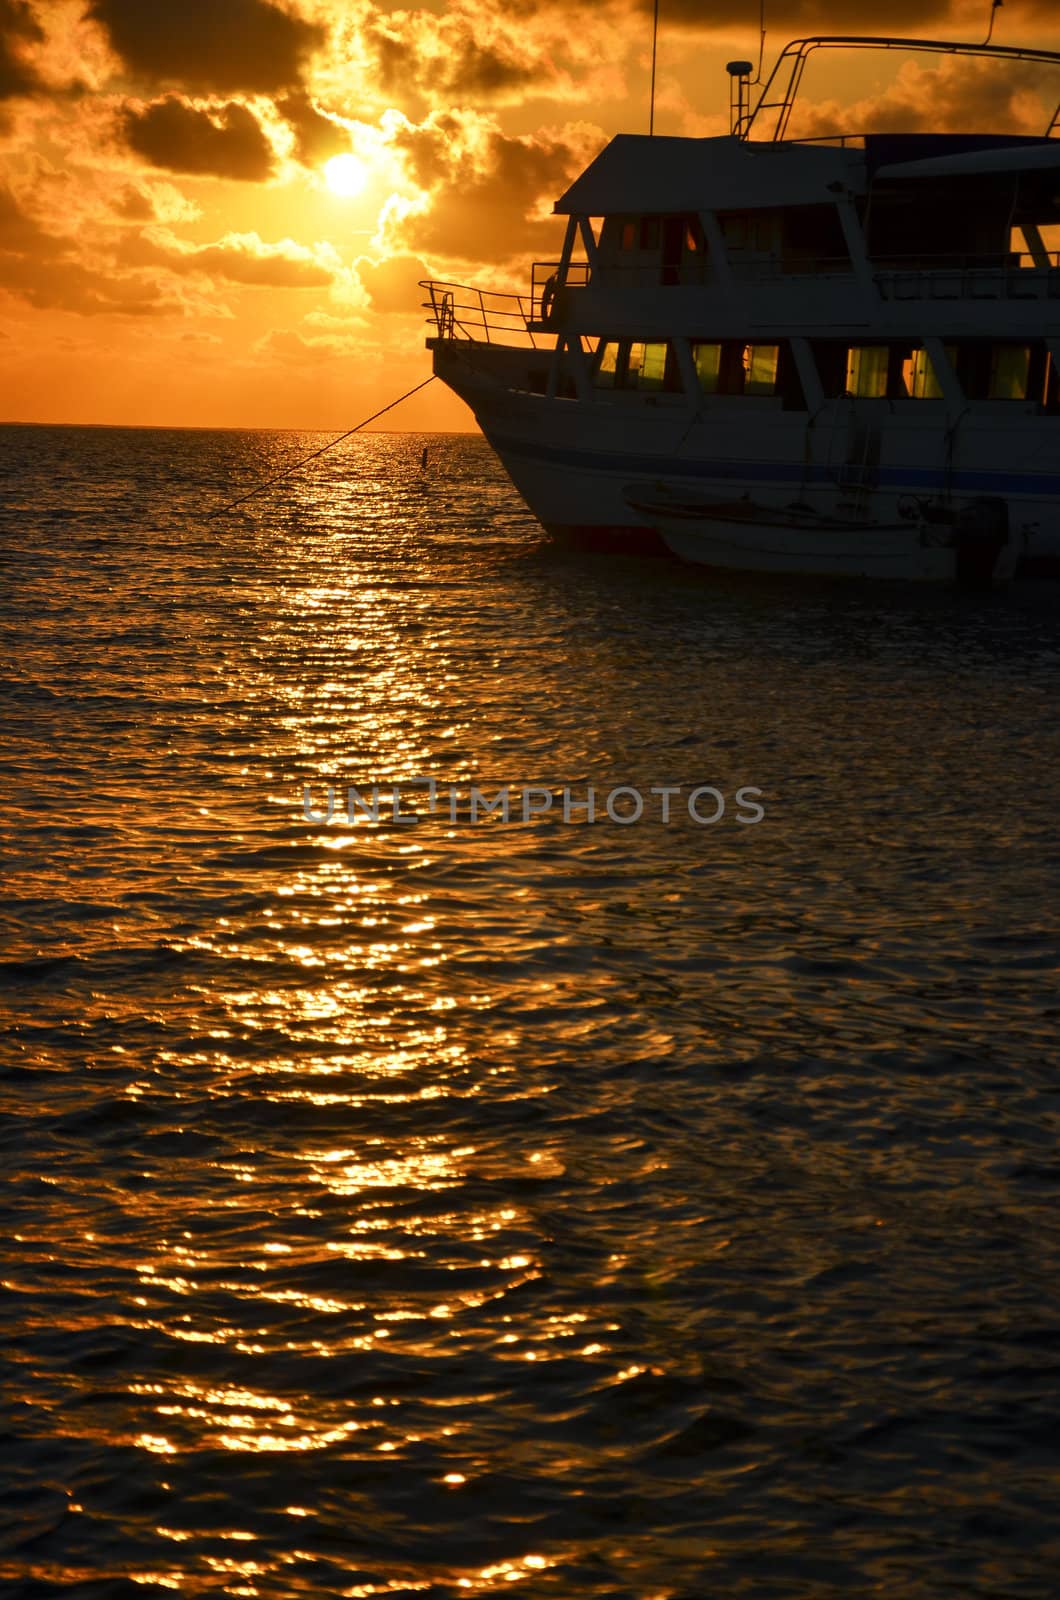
[0,0,1060,430]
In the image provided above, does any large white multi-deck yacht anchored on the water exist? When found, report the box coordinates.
[423,35,1060,576]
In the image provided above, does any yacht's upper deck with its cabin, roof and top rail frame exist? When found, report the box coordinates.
[422,35,1060,350]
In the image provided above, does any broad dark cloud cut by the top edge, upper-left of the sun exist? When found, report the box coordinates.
[88,0,325,94]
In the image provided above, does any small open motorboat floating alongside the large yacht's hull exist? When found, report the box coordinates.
[624,483,1018,587]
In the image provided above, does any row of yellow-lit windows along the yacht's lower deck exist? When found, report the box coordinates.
[592,339,1060,411]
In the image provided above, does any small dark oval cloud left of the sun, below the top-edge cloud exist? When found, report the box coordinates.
[123,94,272,181]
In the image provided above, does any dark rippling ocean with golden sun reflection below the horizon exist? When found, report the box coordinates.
[0,427,1060,1600]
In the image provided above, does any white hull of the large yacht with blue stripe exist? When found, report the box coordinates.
[436,347,1060,582]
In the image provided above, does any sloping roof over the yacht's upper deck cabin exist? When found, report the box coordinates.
[554,133,1060,216]
